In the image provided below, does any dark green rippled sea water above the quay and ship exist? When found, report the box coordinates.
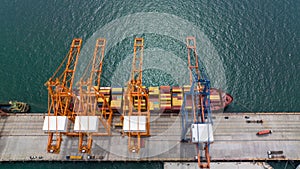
[0,0,300,166]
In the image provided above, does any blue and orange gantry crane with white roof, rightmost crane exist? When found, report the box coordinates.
[181,37,213,168]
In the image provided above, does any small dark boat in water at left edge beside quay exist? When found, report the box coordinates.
[0,101,30,113]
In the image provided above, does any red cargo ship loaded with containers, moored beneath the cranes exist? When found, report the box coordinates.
[75,86,233,114]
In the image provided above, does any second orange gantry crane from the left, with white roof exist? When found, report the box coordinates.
[74,38,113,153]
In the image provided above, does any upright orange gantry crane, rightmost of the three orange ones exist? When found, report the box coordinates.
[122,38,150,153]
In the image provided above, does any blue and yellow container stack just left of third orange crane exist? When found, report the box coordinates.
[111,87,123,113]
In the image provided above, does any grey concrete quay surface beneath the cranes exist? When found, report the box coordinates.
[0,112,300,162]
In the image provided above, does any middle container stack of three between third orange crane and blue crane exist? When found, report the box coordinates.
[160,86,172,112]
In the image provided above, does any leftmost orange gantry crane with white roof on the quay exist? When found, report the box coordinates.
[43,39,82,153]
